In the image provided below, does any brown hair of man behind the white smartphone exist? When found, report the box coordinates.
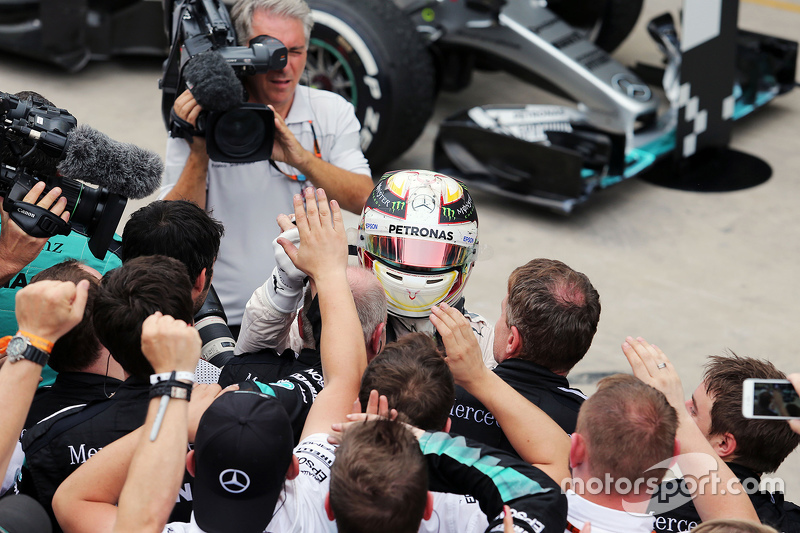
[703,352,800,474]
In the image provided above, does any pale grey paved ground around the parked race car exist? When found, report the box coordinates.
[0,0,800,501]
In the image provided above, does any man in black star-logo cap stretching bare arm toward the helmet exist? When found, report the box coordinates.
[55,189,367,533]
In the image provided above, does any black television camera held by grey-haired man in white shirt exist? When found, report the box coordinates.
[160,0,287,163]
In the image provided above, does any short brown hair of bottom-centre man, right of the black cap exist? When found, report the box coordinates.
[330,420,428,533]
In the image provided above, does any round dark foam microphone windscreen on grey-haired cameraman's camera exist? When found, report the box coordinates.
[183,50,244,111]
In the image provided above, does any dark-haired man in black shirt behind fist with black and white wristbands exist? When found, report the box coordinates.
[20,256,197,531]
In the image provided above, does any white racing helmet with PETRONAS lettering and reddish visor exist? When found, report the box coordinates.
[358,170,478,318]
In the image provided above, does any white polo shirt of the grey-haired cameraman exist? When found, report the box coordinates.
[165,85,371,324]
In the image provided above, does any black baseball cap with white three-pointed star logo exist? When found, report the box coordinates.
[193,391,294,533]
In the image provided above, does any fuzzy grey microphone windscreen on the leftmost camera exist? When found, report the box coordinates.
[58,124,164,199]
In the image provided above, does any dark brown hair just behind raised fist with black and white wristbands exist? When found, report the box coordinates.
[92,255,193,379]
